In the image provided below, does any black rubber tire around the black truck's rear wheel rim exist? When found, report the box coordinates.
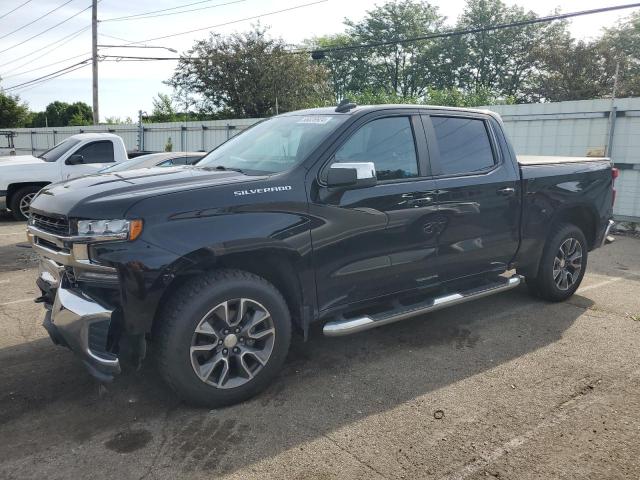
[526,223,588,302]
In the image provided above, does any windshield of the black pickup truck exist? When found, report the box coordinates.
[196,115,347,175]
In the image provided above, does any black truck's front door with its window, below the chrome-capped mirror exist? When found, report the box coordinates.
[310,111,438,311]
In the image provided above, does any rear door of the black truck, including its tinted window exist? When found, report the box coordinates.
[423,112,521,281]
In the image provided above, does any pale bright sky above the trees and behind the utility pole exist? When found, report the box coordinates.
[0,0,633,121]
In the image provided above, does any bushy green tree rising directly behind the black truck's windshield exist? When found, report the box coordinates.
[167,26,330,117]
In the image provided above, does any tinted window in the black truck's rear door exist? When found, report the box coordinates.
[431,117,494,175]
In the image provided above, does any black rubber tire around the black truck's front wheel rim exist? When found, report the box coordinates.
[156,270,291,408]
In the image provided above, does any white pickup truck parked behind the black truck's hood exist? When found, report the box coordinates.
[0,133,128,220]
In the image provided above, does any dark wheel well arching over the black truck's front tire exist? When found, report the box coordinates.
[156,250,304,334]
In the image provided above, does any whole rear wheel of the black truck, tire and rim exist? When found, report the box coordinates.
[526,223,588,302]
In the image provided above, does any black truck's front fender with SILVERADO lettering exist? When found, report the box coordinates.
[96,174,315,333]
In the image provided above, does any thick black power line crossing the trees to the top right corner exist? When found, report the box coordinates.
[302,3,640,53]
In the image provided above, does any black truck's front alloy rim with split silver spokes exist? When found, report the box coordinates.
[190,298,276,388]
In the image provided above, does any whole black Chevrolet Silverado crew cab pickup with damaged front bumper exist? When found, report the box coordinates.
[28,104,616,406]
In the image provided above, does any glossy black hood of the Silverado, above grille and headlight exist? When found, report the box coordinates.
[31,167,262,218]
